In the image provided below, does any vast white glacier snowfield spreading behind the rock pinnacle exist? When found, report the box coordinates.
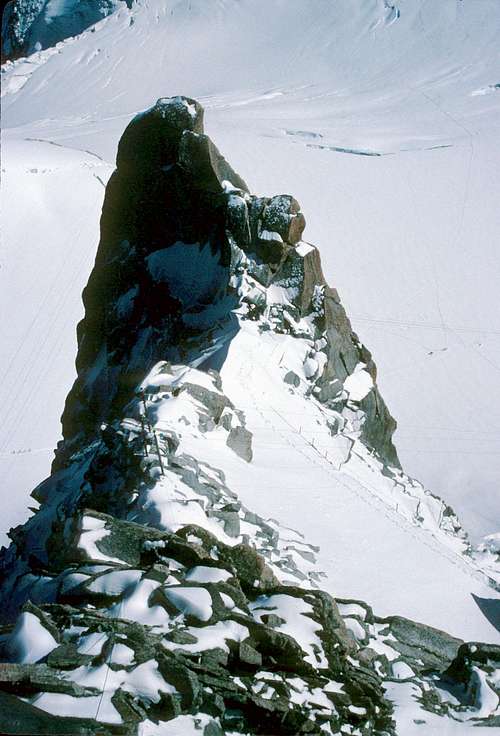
[1,0,500,548]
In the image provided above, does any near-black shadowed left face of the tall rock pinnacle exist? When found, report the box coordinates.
[57,97,238,465]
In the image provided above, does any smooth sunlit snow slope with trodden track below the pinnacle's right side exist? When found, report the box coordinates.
[163,322,500,642]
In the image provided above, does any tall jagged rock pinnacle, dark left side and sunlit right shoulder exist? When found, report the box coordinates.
[56,97,399,467]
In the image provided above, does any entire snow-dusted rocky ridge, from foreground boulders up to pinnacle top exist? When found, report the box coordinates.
[0,97,499,736]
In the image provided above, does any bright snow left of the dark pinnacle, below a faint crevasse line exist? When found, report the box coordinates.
[0,141,112,539]
